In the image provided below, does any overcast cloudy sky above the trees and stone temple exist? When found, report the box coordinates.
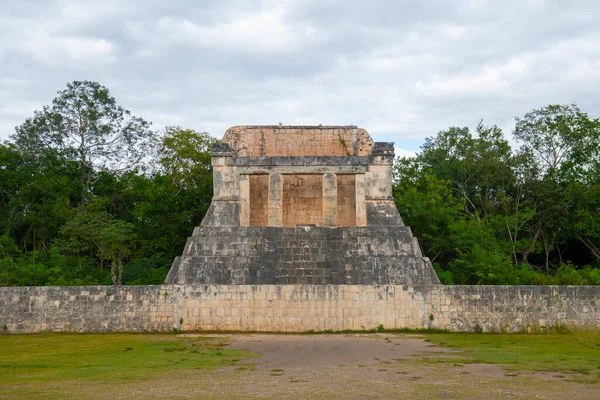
[0,0,600,155]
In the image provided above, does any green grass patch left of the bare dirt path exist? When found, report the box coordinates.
[0,334,255,387]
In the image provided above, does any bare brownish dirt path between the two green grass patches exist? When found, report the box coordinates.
[221,334,600,399]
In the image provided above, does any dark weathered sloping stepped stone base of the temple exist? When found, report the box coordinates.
[165,225,439,285]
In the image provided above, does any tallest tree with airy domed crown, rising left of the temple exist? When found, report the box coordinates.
[12,81,154,204]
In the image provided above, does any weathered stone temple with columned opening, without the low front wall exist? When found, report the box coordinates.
[165,125,439,285]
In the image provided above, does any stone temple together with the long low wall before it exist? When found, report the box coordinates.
[0,126,600,334]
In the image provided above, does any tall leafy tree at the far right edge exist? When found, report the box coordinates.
[514,104,600,268]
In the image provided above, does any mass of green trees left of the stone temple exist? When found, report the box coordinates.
[0,81,215,286]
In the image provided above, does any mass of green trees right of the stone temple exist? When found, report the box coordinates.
[394,105,600,285]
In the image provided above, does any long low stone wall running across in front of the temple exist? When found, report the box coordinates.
[0,285,600,333]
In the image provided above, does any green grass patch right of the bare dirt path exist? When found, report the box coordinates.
[424,331,600,382]
